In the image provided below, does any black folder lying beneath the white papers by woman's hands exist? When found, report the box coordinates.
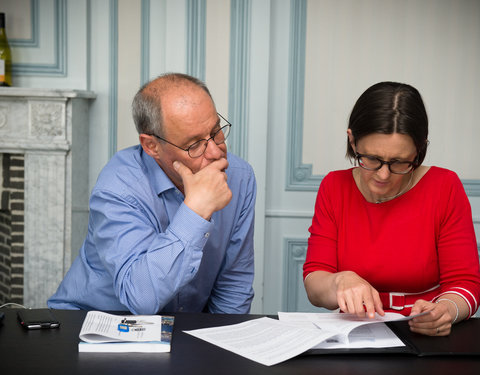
[305,318,480,357]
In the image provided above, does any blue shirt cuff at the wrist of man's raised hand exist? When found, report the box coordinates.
[169,203,214,248]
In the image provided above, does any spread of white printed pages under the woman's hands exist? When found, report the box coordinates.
[184,312,426,366]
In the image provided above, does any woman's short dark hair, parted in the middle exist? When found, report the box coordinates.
[347,82,428,166]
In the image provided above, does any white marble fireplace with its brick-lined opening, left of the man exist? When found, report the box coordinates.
[0,88,95,308]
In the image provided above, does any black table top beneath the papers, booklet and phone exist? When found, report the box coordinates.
[0,309,480,375]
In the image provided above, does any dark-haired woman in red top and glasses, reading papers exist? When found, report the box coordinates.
[303,82,480,336]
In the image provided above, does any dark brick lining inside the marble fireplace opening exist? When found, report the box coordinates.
[0,154,25,304]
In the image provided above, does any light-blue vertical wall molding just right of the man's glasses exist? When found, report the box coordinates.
[228,0,252,159]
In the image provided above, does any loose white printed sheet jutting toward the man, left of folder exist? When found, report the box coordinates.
[184,317,335,366]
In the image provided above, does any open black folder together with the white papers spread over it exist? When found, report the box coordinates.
[184,313,480,366]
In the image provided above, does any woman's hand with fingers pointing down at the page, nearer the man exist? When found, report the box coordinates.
[334,271,385,318]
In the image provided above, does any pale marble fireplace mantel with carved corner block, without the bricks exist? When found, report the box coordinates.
[0,87,95,307]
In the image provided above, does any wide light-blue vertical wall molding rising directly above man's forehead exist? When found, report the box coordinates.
[186,0,207,81]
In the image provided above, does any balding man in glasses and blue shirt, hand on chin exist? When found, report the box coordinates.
[48,73,256,314]
